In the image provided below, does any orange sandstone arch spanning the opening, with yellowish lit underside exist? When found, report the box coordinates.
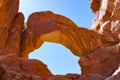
[20,11,102,57]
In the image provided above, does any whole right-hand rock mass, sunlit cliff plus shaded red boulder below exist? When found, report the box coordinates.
[79,0,120,80]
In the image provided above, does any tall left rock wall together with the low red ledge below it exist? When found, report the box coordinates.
[0,0,52,80]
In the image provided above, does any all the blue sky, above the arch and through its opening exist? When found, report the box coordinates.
[19,0,94,74]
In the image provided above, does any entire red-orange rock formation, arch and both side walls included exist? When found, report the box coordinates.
[0,0,120,80]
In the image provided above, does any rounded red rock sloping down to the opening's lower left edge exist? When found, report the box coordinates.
[20,59,52,80]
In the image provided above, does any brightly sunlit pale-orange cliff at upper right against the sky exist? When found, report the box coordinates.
[90,0,120,44]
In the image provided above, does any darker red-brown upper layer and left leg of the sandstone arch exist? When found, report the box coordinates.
[22,11,76,57]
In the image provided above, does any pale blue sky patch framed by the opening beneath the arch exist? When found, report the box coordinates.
[29,42,81,75]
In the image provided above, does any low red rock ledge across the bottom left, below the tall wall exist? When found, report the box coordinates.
[0,54,52,80]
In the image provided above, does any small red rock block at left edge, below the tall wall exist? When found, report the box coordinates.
[0,54,20,72]
